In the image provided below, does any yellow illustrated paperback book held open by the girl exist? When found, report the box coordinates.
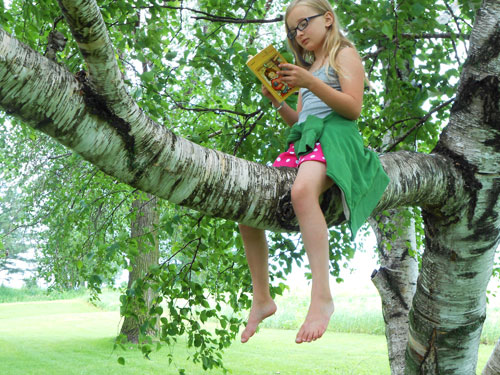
[247,44,299,103]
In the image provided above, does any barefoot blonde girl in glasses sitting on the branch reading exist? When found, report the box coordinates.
[239,0,388,343]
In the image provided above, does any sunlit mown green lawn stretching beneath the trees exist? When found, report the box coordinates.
[0,299,493,375]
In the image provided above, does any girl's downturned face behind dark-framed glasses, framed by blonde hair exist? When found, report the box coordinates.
[287,5,333,54]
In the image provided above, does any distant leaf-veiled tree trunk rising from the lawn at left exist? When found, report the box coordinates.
[121,194,160,343]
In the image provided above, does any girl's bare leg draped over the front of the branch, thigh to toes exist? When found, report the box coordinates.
[292,161,334,344]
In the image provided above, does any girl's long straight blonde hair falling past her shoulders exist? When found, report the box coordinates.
[285,0,356,76]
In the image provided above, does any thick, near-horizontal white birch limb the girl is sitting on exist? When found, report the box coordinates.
[0,25,468,231]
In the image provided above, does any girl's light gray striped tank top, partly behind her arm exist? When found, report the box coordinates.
[298,66,342,123]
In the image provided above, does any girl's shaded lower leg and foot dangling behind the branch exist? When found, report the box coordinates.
[239,224,276,342]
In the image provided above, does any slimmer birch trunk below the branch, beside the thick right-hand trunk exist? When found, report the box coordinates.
[370,209,418,375]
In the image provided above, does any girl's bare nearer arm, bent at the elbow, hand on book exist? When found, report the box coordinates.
[280,48,365,120]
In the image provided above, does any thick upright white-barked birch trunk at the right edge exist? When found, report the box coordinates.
[406,0,500,375]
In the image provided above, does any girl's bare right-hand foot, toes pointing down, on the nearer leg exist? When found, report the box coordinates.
[295,299,335,344]
